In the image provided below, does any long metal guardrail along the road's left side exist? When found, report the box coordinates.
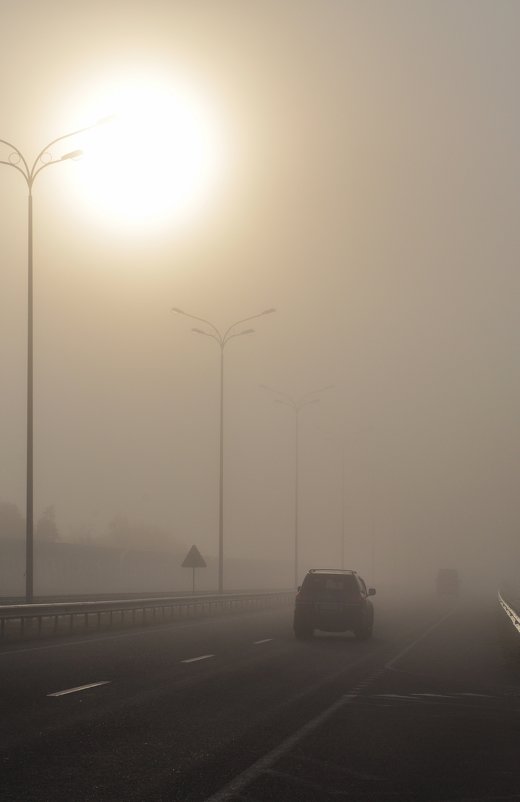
[0,590,294,640]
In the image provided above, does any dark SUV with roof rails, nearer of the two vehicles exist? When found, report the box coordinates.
[294,568,376,640]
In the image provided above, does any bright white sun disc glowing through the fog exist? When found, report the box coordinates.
[78,80,224,226]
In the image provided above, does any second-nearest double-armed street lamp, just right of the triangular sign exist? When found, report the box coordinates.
[171,307,276,593]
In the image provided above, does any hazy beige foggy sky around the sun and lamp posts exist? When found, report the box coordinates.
[0,0,520,588]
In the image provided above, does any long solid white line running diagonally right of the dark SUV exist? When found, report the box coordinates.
[205,609,455,802]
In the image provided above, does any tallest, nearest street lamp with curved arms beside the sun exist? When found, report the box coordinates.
[0,117,112,604]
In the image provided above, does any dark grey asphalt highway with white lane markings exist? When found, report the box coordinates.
[0,594,520,802]
